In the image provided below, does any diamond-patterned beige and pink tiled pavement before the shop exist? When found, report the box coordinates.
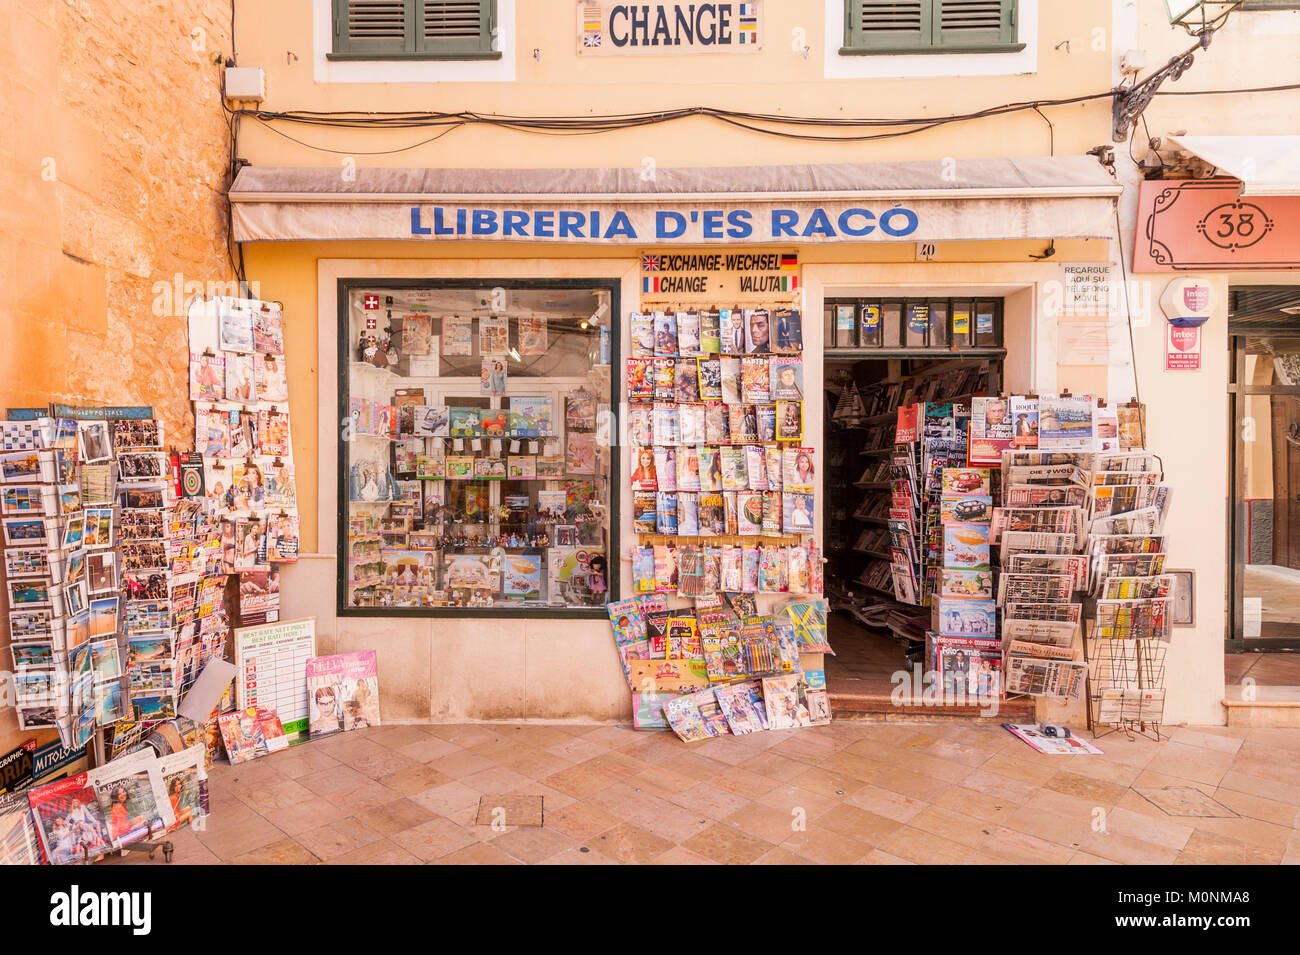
[109,721,1300,865]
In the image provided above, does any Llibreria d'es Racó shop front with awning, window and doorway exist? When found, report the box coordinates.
[230,156,1227,728]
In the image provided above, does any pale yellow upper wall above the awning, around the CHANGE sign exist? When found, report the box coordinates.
[237,0,1112,168]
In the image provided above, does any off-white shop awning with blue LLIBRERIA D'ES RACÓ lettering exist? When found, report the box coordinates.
[230,156,1119,246]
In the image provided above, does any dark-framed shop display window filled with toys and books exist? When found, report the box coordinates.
[338,279,619,616]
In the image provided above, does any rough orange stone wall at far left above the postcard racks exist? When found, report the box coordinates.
[0,0,233,752]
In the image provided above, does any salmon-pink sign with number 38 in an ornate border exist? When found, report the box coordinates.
[1134,179,1300,272]
